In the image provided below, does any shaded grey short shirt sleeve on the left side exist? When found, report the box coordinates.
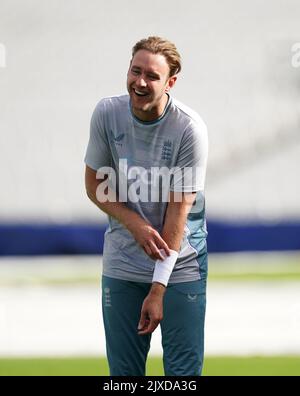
[84,101,111,170]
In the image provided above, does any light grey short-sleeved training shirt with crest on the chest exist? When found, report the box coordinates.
[85,95,208,283]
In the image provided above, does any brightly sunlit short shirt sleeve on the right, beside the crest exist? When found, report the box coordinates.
[170,120,208,193]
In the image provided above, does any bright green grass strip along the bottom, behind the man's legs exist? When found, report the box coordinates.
[0,356,300,376]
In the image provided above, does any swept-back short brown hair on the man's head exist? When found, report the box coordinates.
[132,36,181,77]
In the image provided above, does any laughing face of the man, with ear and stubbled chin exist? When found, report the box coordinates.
[127,50,177,121]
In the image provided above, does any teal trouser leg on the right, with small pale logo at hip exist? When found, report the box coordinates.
[161,279,206,375]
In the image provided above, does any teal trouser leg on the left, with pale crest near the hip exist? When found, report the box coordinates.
[102,276,151,376]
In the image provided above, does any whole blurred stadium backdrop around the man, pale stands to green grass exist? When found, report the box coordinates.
[0,0,300,375]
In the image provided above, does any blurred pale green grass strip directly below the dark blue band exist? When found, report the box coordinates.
[0,252,300,287]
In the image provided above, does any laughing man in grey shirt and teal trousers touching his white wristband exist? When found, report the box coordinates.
[85,37,207,376]
